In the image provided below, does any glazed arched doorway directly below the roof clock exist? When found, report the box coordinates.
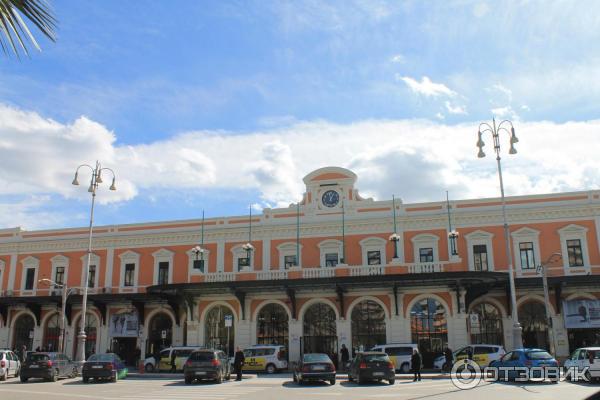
[300,303,337,362]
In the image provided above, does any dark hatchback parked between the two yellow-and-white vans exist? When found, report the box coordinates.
[183,350,231,385]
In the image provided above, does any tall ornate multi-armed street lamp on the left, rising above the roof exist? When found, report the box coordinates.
[72,161,117,362]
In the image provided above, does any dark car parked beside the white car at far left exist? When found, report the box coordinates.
[20,352,77,383]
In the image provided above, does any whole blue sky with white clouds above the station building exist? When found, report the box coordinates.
[0,0,600,228]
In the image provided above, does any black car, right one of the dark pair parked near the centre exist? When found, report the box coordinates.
[348,351,396,385]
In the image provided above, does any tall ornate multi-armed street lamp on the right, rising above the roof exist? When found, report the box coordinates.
[477,119,523,348]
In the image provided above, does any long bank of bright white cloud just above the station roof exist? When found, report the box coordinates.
[0,106,600,226]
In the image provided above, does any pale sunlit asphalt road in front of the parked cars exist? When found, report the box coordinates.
[0,374,600,400]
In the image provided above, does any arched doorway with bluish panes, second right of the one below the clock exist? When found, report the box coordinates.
[410,298,448,368]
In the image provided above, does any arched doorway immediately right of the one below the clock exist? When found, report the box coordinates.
[350,300,386,351]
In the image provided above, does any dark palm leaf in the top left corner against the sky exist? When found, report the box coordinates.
[0,0,56,57]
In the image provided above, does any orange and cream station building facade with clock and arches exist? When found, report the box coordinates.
[0,167,600,365]
